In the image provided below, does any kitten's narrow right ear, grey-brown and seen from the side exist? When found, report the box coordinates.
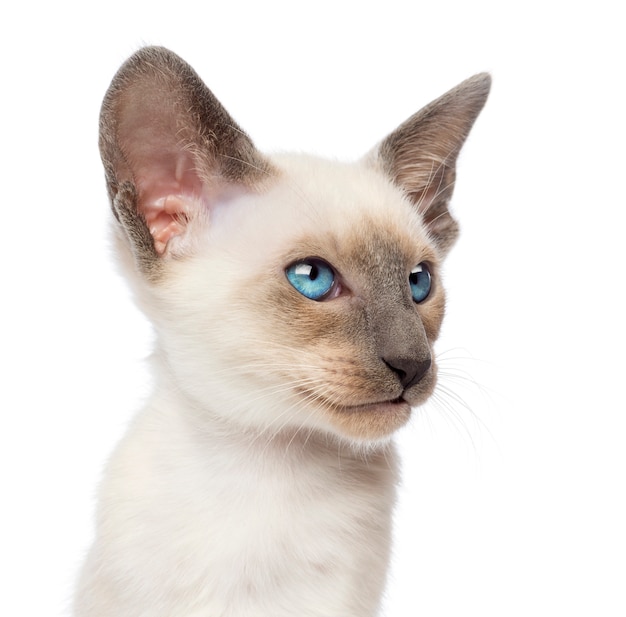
[370,73,491,255]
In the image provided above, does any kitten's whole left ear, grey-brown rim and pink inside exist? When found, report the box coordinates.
[100,47,272,276]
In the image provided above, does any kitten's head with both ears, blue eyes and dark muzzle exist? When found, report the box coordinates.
[100,47,490,443]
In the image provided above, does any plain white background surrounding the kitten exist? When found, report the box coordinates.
[0,0,626,617]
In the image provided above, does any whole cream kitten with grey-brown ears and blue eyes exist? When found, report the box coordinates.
[75,48,490,617]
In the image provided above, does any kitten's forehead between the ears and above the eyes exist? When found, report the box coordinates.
[268,157,436,270]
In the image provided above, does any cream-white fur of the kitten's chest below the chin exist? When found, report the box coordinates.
[84,404,396,617]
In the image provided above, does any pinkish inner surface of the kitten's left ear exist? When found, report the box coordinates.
[101,57,218,255]
